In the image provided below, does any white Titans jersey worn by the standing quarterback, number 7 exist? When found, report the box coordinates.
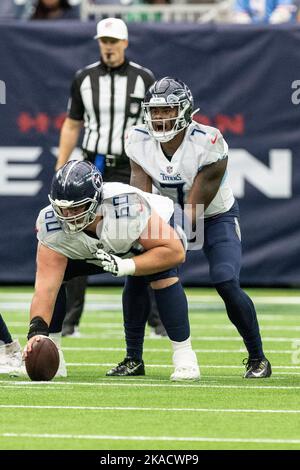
[125,121,234,217]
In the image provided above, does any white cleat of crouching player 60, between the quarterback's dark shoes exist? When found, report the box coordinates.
[170,349,200,382]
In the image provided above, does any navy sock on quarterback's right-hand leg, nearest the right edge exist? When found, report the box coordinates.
[215,280,264,359]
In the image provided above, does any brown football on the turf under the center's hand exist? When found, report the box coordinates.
[25,336,59,381]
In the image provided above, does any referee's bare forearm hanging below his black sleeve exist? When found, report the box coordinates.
[55,117,82,170]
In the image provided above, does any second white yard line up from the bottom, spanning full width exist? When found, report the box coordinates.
[0,405,300,414]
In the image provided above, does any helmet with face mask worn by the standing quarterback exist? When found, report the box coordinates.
[142,77,194,142]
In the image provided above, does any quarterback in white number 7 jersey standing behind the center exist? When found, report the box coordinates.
[125,77,272,378]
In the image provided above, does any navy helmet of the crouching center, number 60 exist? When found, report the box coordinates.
[48,160,103,233]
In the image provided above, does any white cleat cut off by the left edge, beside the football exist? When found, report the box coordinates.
[0,340,24,377]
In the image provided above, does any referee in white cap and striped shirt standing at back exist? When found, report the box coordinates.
[56,18,165,344]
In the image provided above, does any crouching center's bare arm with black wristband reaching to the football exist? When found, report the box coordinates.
[24,243,67,357]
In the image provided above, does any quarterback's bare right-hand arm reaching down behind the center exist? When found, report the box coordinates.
[187,157,228,224]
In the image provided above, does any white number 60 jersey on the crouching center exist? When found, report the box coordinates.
[36,183,174,266]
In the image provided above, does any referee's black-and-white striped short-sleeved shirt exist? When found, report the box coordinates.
[68,59,154,156]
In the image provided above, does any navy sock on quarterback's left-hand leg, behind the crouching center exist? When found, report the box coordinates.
[122,276,150,361]
